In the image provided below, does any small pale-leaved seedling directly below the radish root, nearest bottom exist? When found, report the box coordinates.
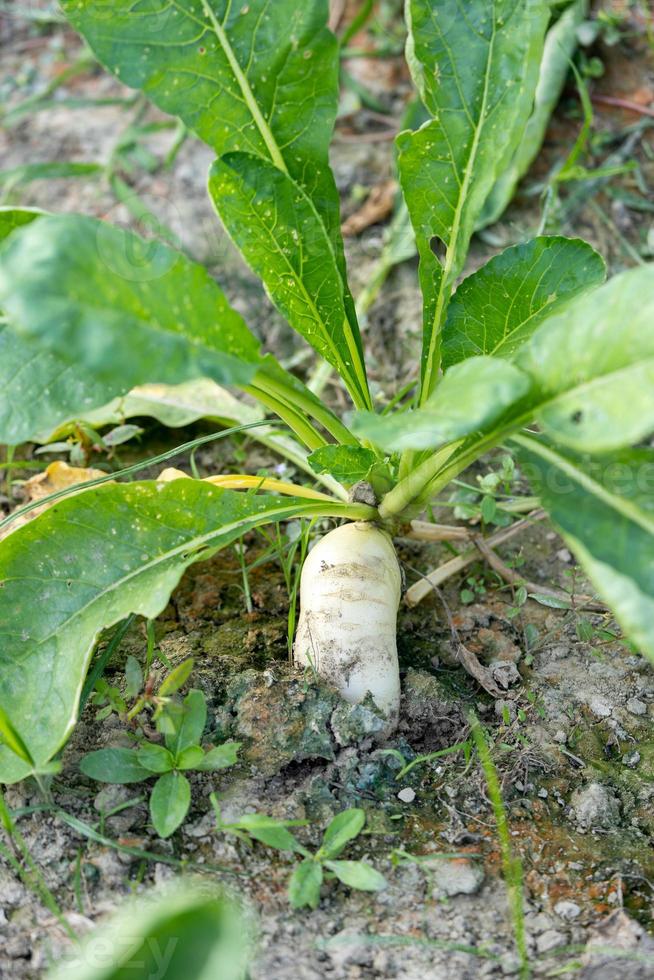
[211,793,386,909]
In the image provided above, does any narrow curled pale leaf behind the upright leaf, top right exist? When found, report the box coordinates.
[477,0,588,228]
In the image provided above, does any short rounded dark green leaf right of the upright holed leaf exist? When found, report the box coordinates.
[443,236,606,368]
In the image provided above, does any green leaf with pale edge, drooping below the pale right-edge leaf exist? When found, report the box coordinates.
[513,436,654,660]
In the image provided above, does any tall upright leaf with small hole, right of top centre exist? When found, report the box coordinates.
[397,0,549,401]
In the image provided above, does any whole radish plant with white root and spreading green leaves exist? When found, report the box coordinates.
[0,0,654,782]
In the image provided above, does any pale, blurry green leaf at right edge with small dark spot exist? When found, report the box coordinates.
[513,266,654,453]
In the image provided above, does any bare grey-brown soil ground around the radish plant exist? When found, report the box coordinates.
[0,3,654,980]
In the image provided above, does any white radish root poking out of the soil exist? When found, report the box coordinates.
[293,522,402,730]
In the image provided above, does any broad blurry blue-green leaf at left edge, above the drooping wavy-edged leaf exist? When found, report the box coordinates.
[0,210,352,443]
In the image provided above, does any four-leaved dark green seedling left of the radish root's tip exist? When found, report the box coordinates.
[80,690,239,837]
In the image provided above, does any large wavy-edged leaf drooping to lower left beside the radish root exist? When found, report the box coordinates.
[0,480,370,782]
